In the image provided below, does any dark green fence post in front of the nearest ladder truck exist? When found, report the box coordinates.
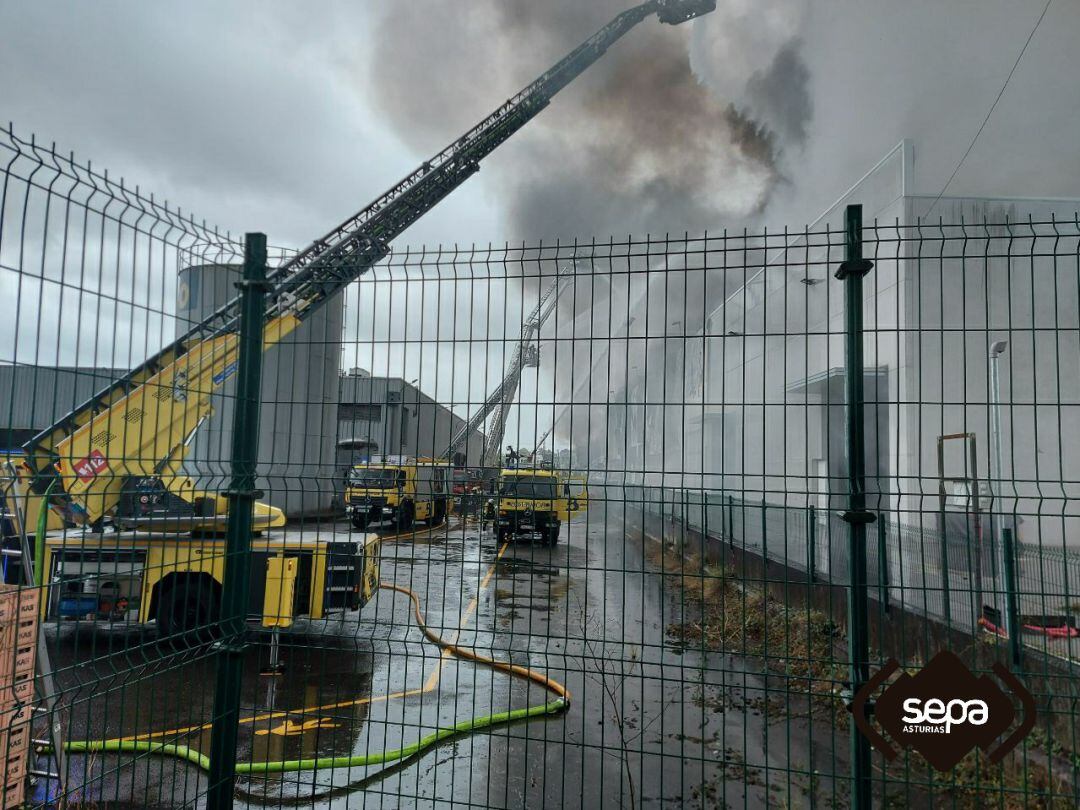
[206,233,267,810]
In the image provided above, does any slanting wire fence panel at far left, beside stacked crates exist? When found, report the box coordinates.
[0,123,251,807]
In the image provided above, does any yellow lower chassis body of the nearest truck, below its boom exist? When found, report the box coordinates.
[42,529,379,636]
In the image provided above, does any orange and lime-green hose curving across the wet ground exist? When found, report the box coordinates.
[43,582,570,775]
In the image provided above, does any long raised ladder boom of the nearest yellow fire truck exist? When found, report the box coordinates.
[14,0,716,529]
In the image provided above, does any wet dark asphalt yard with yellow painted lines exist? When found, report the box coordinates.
[42,503,847,808]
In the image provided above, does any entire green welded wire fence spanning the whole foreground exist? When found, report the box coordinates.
[6,115,1080,808]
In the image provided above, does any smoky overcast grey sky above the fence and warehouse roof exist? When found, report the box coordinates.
[0,0,1080,244]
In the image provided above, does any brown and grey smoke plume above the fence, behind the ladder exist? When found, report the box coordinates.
[373,0,811,240]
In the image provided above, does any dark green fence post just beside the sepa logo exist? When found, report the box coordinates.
[836,205,874,810]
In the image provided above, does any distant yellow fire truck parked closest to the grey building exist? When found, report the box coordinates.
[345,456,450,531]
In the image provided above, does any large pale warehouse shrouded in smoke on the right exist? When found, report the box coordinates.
[575,141,1080,581]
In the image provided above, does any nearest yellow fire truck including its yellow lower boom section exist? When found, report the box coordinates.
[3,315,378,635]
